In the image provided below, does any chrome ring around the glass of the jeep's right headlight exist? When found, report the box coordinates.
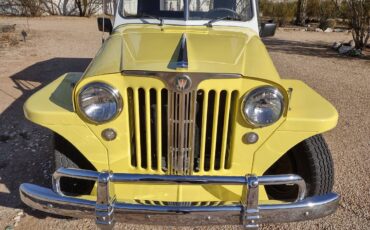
[240,85,286,128]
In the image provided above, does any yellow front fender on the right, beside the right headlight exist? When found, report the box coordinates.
[252,80,338,198]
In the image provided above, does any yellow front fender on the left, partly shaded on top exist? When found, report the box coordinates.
[23,73,109,171]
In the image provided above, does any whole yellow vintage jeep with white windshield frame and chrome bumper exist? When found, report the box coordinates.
[20,0,340,229]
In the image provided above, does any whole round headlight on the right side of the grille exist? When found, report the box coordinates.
[242,86,284,126]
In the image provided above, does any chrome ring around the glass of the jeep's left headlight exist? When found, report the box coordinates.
[76,82,123,124]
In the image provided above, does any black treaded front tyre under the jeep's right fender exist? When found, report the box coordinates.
[265,135,334,200]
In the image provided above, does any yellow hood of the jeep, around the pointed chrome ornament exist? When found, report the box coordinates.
[85,25,279,80]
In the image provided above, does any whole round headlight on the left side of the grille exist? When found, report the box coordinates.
[78,83,122,123]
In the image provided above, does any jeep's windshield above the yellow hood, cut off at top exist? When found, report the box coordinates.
[120,0,253,21]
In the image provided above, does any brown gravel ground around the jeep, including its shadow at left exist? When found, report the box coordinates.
[0,17,370,230]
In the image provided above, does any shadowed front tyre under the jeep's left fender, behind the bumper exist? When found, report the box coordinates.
[54,134,96,196]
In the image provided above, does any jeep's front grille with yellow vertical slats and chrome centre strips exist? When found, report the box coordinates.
[127,88,238,175]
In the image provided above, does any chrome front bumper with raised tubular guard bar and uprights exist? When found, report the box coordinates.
[20,168,340,229]
